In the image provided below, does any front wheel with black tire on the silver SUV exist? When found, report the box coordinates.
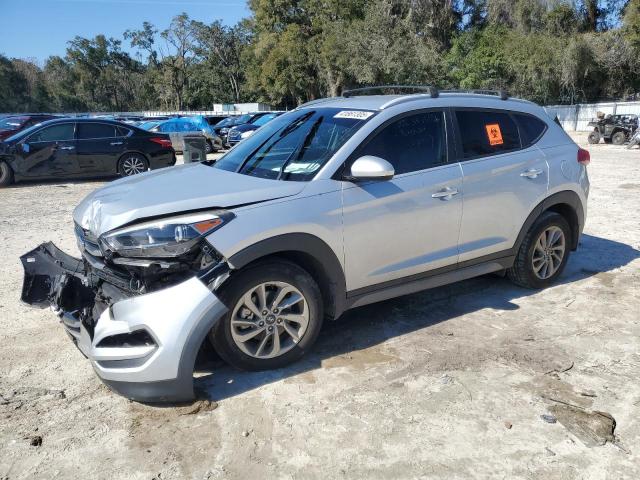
[209,260,324,371]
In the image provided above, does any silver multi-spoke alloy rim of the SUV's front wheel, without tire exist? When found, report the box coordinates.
[231,281,309,359]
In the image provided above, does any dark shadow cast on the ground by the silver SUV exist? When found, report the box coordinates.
[195,235,640,400]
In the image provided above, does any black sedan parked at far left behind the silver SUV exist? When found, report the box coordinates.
[0,118,176,186]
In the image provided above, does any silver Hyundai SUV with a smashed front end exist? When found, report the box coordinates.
[22,88,589,401]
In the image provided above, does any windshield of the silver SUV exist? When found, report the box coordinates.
[211,108,375,181]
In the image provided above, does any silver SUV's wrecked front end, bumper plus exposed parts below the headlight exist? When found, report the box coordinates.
[21,226,230,402]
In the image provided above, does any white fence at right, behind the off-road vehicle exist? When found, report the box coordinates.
[544,102,640,132]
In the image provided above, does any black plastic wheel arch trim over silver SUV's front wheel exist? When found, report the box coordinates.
[229,233,347,319]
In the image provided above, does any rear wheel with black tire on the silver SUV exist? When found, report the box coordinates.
[507,212,571,289]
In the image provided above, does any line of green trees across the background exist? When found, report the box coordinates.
[0,0,640,112]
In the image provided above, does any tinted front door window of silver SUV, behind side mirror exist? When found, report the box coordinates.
[358,112,447,175]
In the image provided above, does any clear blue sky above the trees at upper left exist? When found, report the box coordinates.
[0,0,249,63]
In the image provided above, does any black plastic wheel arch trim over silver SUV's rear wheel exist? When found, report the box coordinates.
[513,190,584,253]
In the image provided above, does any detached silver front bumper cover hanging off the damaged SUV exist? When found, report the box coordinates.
[20,243,227,402]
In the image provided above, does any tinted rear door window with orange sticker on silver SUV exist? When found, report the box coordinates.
[456,110,520,158]
